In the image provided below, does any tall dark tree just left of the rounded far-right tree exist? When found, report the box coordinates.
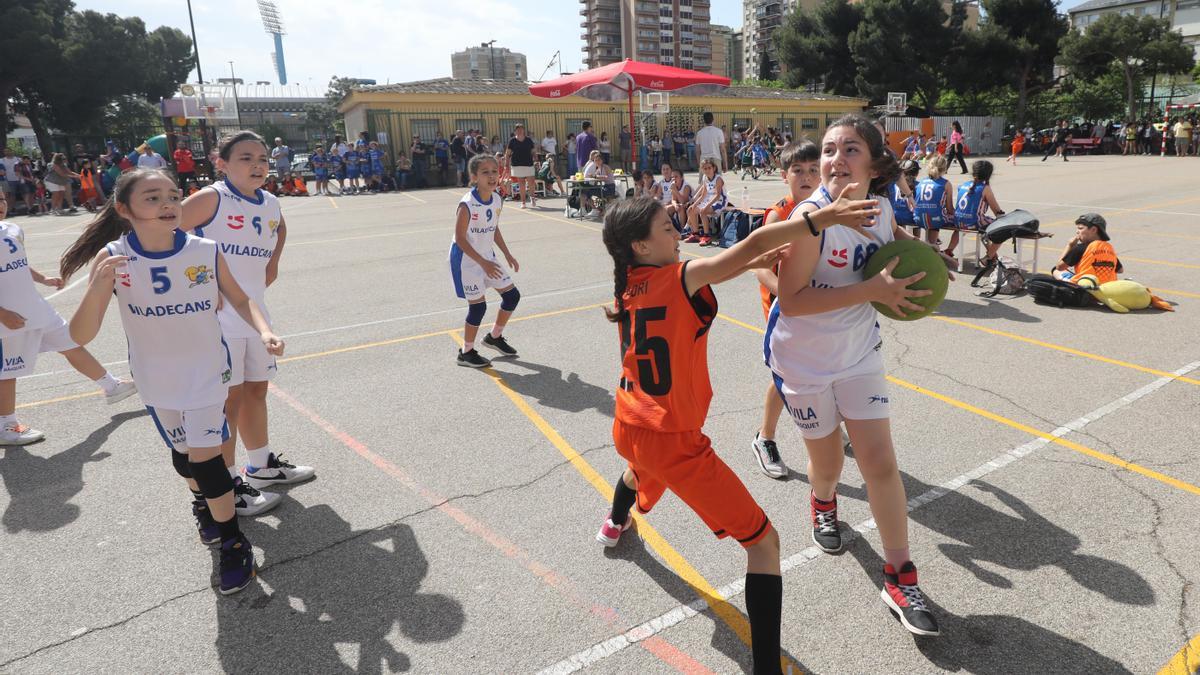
[979,0,1069,120]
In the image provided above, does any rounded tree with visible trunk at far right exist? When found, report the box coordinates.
[1058,14,1195,119]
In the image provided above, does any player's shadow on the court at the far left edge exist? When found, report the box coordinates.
[0,408,144,533]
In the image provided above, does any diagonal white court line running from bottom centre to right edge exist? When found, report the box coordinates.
[538,362,1200,675]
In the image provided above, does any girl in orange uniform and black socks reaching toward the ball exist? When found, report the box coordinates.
[596,184,880,674]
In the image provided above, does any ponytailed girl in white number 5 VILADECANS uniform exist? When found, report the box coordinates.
[61,169,283,595]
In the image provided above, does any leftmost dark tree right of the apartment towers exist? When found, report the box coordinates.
[774,0,863,96]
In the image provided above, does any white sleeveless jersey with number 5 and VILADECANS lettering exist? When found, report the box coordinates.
[108,231,232,411]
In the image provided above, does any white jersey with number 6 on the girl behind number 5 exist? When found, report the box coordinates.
[196,180,283,339]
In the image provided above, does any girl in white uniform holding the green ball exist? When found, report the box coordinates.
[764,115,938,635]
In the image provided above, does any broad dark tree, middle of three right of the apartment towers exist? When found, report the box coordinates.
[850,0,955,114]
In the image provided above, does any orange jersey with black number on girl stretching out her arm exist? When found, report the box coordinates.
[617,263,716,431]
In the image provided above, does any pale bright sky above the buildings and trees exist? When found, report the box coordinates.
[76,0,1082,91]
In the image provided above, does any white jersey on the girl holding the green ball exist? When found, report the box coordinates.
[764,186,895,387]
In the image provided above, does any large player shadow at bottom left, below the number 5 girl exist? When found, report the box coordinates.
[216,497,466,674]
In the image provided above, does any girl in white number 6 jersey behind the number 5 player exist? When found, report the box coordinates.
[179,131,316,515]
